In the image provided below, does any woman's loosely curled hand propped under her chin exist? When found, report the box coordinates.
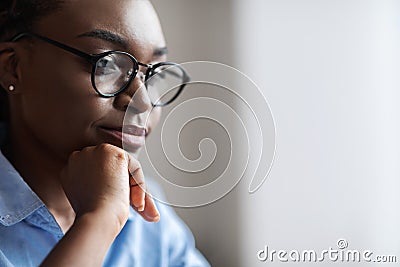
[61,144,160,230]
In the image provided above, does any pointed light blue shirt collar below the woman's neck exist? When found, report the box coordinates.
[0,151,44,226]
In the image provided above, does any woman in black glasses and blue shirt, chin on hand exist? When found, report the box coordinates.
[0,0,208,266]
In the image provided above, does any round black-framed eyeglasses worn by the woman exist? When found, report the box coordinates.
[11,32,190,107]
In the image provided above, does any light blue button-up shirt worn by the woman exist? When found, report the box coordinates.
[0,152,209,267]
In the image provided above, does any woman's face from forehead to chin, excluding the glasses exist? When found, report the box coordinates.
[11,0,166,158]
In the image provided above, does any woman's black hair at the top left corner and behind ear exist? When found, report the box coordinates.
[0,0,65,121]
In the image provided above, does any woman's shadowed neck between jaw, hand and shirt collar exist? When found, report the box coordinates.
[4,118,75,232]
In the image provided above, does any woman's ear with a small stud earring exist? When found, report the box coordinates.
[0,42,20,94]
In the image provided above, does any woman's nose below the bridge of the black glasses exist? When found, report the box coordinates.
[114,71,153,114]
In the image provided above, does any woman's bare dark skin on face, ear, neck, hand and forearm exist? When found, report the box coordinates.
[0,0,166,266]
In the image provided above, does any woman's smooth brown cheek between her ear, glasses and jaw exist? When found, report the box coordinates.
[21,55,111,156]
